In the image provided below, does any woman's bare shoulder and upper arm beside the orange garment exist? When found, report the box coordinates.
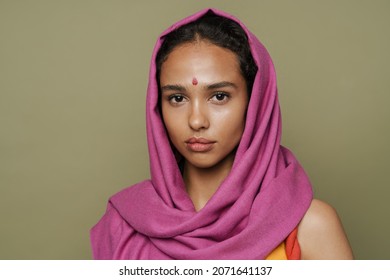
[298,199,353,260]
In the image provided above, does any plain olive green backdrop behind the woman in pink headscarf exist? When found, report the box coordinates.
[0,0,390,259]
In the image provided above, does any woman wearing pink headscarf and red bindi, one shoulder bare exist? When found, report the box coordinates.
[91,7,352,259]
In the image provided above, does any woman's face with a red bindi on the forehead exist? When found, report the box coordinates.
[160,41,248,168]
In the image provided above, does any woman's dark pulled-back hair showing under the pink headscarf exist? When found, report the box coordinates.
[156,11,257,95]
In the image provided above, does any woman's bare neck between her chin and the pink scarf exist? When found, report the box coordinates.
[183,153,234,211]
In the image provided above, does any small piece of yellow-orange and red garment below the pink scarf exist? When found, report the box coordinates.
[266,228,301,260]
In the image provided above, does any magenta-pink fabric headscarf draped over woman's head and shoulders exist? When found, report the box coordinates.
[91,9,312,259]
